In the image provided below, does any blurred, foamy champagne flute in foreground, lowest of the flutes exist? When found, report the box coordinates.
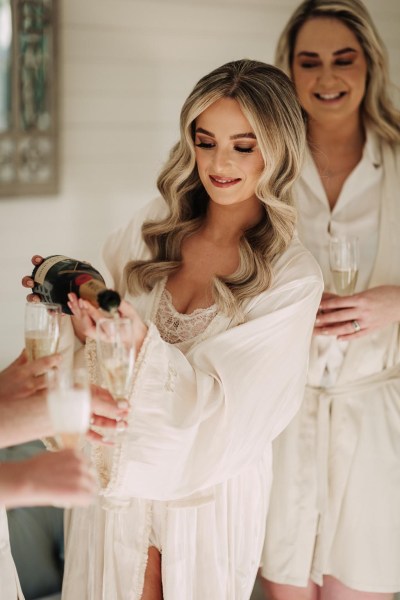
[47,367,91,449]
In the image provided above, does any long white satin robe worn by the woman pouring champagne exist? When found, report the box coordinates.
[62,200,322,600]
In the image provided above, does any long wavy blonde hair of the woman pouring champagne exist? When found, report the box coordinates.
[125,59,305,316]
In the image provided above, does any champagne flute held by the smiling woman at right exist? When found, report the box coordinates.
[329,235,359,296]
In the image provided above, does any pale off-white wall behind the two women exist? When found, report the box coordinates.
[0,0,400,368]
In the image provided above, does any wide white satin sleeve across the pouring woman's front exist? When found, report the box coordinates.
[104,244,322,500]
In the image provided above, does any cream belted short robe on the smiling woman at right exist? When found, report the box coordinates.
[262,133,400,592]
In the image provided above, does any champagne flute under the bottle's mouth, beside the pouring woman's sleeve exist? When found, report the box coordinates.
[96,318,135,412]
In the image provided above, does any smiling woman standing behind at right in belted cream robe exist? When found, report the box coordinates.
[262,0,400,600]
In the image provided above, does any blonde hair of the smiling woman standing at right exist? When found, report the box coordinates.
[275,0,400,143]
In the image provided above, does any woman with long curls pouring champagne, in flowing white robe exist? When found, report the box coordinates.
[54,60,322,600]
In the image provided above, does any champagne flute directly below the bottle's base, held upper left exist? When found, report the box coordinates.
[25,302,61,361]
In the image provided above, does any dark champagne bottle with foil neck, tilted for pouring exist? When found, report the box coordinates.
[32,254,121,315]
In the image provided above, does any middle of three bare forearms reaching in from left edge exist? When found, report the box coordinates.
[0,394,54,447]
